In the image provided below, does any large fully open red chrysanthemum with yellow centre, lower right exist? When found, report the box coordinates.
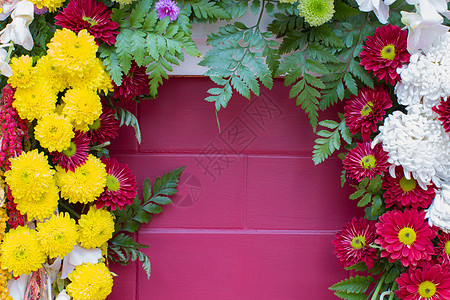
[375,209,436,268]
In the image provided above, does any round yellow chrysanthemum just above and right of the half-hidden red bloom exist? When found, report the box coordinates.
[63,88,102,132]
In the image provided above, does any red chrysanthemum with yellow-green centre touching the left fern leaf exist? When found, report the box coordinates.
[96,157,137,210]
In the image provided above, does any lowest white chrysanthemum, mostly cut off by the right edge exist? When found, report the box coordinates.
[425,182,450,232]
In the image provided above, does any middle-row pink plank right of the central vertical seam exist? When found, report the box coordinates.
[247,156,362,229]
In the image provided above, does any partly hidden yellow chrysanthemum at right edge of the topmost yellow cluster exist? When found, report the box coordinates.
[69,59,113,94]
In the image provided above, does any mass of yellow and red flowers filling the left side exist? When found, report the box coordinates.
[0,0,188,300]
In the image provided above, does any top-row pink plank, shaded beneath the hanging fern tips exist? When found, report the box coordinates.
[139,78,342,154]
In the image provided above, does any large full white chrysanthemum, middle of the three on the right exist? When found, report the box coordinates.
[373,111,450,189]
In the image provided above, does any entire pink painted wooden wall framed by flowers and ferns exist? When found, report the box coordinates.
[109,78,361,300]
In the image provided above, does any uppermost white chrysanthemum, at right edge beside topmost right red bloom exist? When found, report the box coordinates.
[395,33,450,116]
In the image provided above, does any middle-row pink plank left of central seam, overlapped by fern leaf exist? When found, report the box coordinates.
[115,154,244,228]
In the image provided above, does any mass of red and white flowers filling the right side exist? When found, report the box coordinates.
[326,1,450,300]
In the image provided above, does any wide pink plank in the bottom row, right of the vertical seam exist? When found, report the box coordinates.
[132,231,348,300]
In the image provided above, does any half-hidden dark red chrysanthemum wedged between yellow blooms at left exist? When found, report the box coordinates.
[50,131,89,172]
